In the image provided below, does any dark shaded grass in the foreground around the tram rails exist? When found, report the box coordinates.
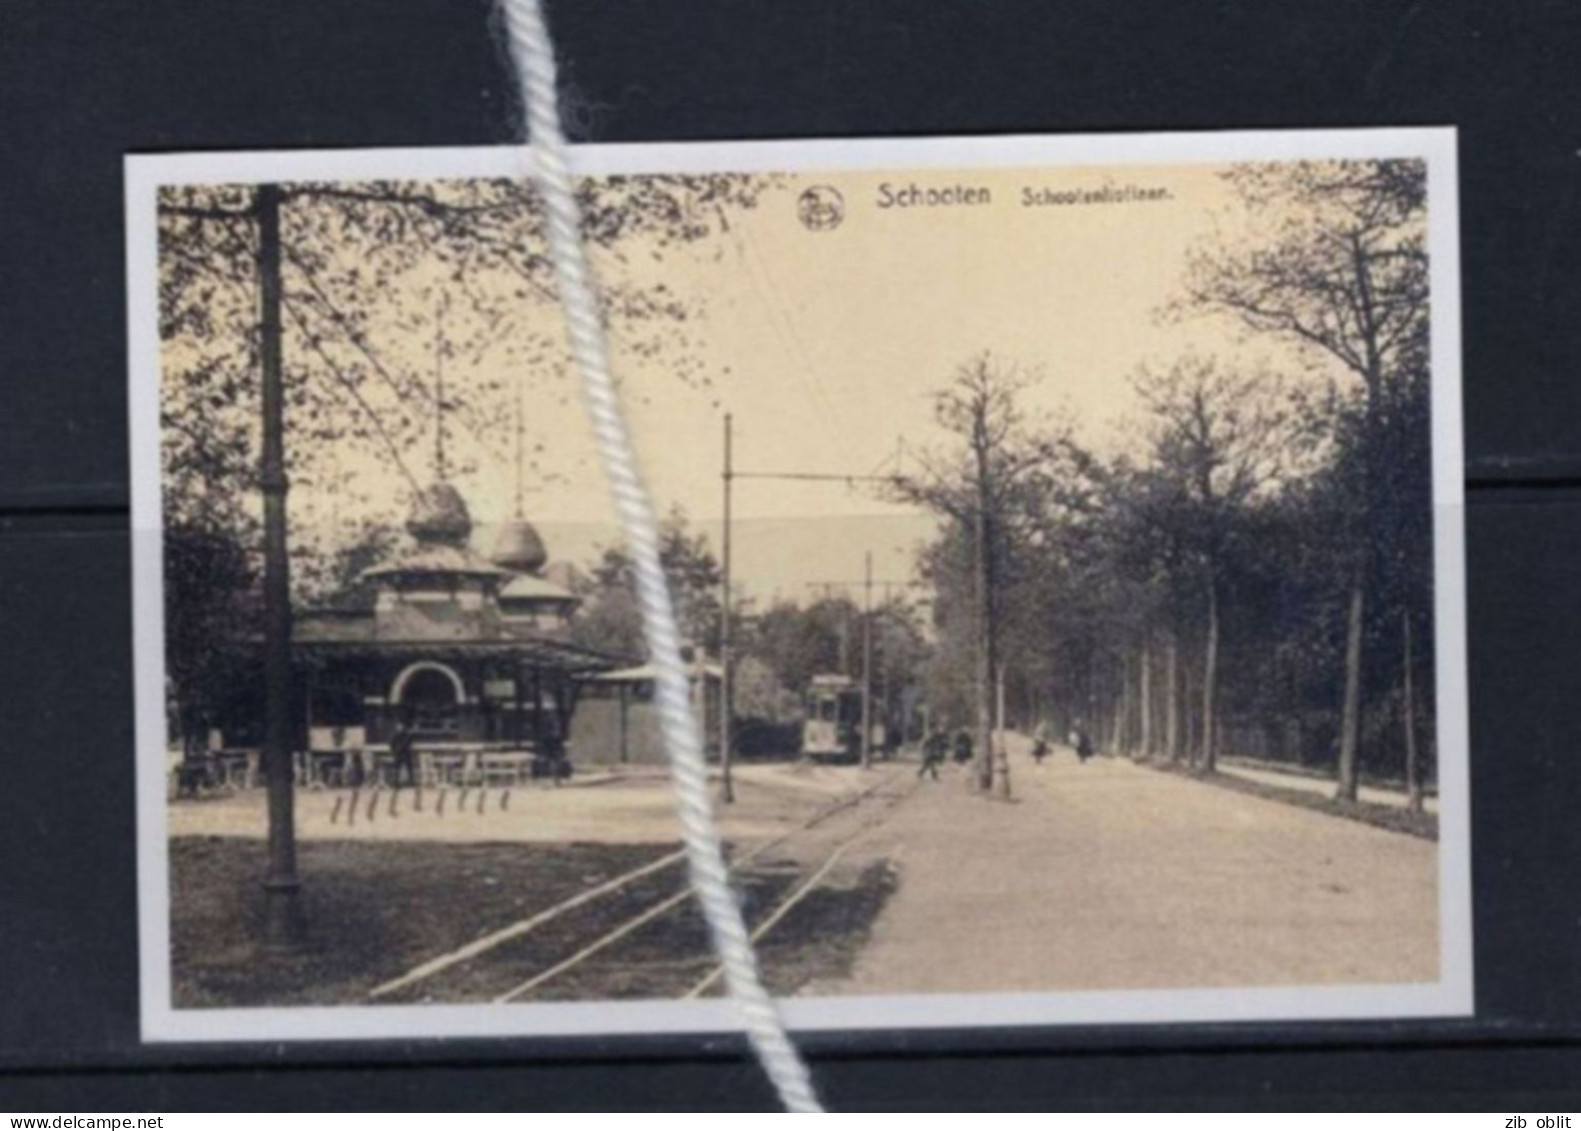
[169,837,893,1009]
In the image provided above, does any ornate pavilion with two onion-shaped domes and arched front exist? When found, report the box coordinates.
[294,481,620,783]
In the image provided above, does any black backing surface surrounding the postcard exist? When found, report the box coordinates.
[0,0,1581,1112]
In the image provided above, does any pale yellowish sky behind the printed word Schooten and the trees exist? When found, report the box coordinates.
[169,166,1309,596]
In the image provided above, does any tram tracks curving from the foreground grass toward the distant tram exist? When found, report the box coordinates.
[370,767,915,1003]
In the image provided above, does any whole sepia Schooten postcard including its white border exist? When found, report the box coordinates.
[126,130,1473,1041]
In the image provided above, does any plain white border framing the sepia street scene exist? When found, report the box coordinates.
[125,128,1475,1041]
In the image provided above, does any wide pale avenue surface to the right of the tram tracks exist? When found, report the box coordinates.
[806,743,1437,995]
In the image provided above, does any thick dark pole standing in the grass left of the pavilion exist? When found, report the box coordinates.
[253,185,302,946]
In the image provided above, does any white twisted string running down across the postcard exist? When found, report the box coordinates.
[500,0,822,1112]
